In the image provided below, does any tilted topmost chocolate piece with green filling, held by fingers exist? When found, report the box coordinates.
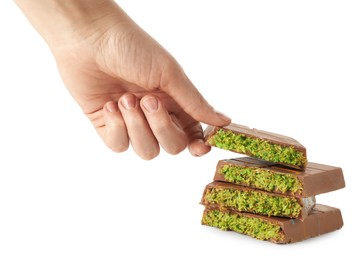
[204,123,307,169]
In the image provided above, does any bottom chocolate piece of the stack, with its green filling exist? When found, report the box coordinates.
[202,204,343,244]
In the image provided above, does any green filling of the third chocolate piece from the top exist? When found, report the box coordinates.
[204,188,302,218]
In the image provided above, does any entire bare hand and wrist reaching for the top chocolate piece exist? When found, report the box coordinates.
[14,0,230,160]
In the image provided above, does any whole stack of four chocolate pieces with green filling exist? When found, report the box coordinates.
[201,124,345,244]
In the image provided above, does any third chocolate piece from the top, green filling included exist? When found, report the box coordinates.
[201,181,315,219]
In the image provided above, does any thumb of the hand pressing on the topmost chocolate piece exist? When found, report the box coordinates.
[161,65,231,126]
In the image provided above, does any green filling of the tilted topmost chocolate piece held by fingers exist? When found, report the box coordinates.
[208,129,307,167]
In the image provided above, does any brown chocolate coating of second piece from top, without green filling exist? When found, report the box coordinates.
[214,157,345,197]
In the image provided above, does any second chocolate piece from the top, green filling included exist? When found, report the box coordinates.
[214,157,345,197]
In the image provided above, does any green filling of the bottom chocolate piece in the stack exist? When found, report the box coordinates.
[202,210,284,242]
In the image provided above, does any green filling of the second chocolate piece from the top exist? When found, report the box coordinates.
[220,165,303,194]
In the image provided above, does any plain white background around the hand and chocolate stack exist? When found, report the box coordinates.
[0,0,363,260]
